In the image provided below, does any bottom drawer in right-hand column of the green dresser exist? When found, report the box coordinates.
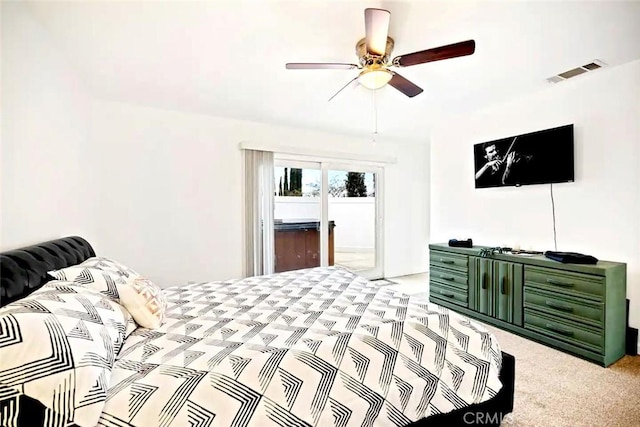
[524,308,604,353]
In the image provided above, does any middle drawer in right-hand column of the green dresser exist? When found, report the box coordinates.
[524,286,604,328]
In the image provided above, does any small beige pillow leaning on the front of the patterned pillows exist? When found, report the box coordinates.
[118,276,167,329]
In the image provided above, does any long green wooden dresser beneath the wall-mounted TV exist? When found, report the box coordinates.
[429,244,627,366]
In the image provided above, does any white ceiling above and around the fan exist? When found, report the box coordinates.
[30,0,640,139]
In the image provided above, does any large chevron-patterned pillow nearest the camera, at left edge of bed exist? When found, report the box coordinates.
[0,281,131,426]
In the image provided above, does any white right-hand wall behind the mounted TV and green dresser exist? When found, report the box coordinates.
[430,61,640,327]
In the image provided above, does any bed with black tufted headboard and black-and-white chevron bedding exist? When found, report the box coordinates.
[0,237,515,427]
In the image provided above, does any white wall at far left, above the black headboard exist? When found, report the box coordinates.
[0,2,89,250]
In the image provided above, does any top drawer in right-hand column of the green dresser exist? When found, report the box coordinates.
[524,265,605,301]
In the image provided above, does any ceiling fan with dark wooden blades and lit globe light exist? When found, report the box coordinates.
[287,8,476,101]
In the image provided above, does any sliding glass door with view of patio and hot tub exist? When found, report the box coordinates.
[274,156,383,279]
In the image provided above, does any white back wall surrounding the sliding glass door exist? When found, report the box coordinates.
[90,101,429,286]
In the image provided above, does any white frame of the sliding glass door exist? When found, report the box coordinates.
[274,153,384,280]
